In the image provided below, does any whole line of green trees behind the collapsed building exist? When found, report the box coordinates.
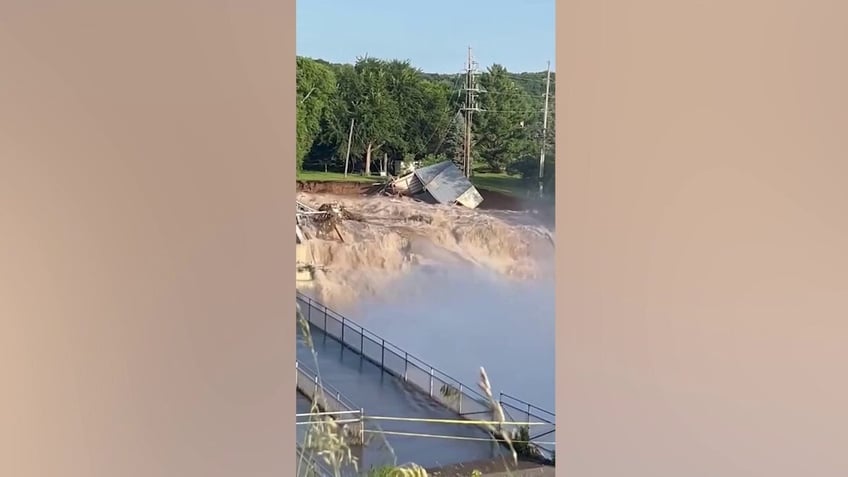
[296,57,556,190]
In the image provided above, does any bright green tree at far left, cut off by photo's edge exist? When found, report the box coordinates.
[295,57,336,170]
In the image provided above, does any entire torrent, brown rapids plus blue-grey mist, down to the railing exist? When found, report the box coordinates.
[298,193,555,411]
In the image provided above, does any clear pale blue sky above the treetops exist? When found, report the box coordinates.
[297,0,556,73]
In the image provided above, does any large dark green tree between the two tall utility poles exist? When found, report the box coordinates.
[473,64,539,172]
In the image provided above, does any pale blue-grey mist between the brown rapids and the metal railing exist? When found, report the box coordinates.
[348,266,555,411]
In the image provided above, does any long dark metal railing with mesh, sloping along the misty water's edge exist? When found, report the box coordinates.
[297,291,556,458]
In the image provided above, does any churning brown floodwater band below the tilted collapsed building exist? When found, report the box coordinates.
[297,193,554,308]
